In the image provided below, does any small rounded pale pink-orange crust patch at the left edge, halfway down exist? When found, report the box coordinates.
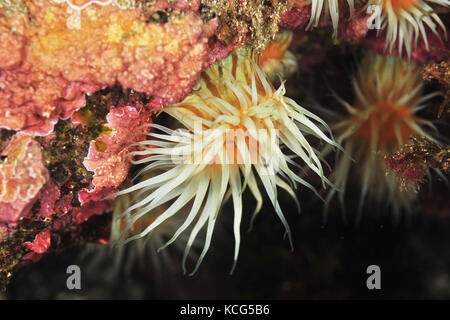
[0,133,49,223]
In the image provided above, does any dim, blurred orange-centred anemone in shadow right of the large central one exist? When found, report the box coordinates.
[325,53,439,222]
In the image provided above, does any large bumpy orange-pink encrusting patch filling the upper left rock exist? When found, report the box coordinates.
[0,0,216,135]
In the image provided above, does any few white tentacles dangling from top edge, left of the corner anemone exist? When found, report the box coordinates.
[306,0,355,39]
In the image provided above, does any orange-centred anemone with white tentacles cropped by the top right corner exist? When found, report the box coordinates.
[369,0,450,57]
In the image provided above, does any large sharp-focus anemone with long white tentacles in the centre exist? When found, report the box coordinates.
[113,48,340,274]
